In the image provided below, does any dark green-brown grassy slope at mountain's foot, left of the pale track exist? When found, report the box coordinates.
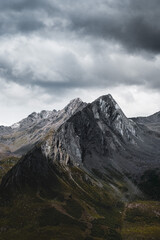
[0,167,123,240]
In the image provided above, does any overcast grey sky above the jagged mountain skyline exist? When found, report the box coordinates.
[0,0,160,125]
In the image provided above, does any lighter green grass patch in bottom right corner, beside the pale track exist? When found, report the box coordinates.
[122,201,160,240]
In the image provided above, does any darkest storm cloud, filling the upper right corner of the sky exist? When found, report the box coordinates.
[68,0,160,54]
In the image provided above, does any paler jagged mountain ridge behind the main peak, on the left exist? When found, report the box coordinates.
[0,98,86,159]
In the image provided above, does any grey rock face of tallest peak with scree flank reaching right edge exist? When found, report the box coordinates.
[49,95,160,175]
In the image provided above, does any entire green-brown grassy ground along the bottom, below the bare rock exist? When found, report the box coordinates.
[0,158,160,240]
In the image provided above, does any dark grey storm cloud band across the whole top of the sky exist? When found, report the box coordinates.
[0,0,160,54]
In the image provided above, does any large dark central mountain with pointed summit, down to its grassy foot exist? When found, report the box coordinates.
[0,95,160,240]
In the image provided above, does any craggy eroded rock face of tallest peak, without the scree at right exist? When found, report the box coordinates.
[43,95,140,170]
